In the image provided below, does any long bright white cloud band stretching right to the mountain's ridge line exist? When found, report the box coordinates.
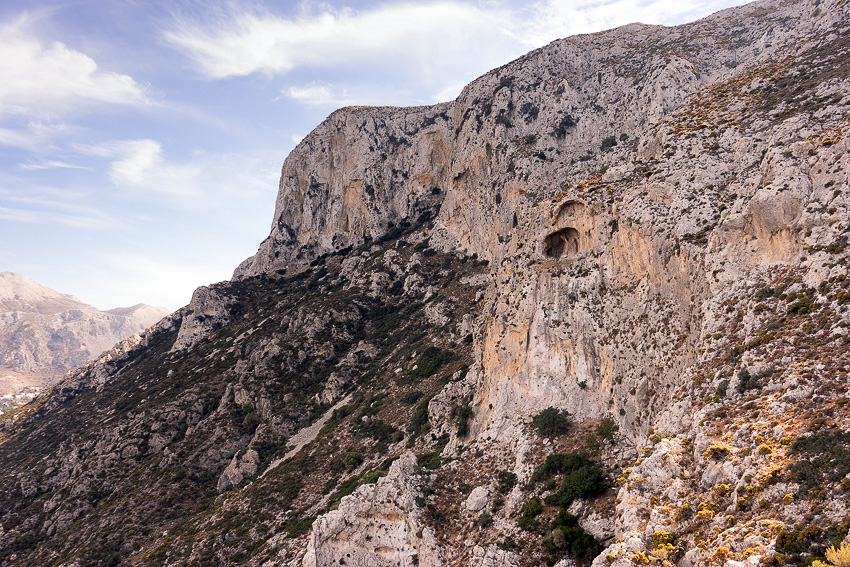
[165,0,744,106]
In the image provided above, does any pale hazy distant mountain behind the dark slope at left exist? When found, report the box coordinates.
[0,272,169,395]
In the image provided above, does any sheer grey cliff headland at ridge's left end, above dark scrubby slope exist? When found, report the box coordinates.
[236,103,454,277]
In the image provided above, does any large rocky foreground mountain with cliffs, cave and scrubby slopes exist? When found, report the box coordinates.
[0,0,850,567]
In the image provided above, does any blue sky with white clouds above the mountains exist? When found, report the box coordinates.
[0,0,744,309]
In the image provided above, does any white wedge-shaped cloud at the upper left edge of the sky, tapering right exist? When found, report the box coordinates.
[0,17,149,117]
